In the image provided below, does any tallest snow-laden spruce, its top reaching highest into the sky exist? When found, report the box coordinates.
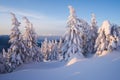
[61,6,83,60]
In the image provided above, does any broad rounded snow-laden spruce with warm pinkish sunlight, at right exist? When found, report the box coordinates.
[95,20,118,55]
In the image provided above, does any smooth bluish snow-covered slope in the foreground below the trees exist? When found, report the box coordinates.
[0,51,120,80]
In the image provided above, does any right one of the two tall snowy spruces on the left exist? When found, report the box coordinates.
[23,17,43,62]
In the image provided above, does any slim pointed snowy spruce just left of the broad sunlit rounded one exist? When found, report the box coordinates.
[87,13,97,53]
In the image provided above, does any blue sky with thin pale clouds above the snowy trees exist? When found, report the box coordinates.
[0,0,120,35]
